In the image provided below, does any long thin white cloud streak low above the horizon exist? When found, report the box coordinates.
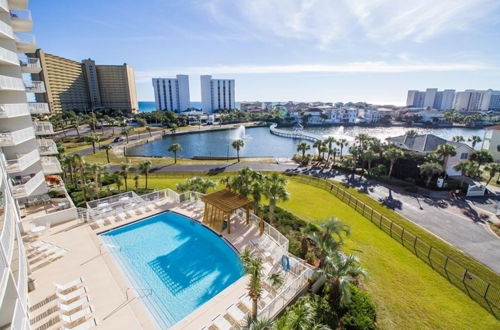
[136,62,488,83]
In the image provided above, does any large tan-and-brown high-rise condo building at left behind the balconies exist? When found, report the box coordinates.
[32,49,138,113]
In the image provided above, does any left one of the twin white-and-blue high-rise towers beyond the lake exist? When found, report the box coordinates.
[153,74,191,112]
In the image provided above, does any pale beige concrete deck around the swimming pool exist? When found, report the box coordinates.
[28,200,300,329]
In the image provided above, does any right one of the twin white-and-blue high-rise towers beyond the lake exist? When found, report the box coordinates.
[200,75,235,113]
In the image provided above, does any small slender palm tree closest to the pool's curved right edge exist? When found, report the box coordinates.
[241,249,264,318]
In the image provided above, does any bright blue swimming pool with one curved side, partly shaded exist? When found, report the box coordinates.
[101,212,243,329]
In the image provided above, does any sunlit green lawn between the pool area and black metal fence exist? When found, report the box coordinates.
[124,174,499,329]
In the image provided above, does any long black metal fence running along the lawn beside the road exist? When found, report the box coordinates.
[292,174,500,319]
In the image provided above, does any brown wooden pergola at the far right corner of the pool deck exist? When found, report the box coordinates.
[201,189,252,234]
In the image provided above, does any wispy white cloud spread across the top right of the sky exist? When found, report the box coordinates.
[206,0,500,48]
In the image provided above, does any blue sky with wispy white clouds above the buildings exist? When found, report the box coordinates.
[30,0,500,105]
